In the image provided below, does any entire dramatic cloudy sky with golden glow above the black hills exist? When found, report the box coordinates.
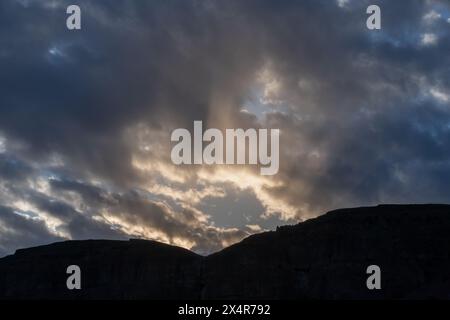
[0,0,450,256]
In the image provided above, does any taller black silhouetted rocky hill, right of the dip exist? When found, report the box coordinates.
[203,205,450,299]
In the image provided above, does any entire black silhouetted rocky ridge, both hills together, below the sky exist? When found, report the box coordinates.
[0,205,450,299]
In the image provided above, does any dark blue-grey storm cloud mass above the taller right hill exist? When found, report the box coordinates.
[241,1,450,214]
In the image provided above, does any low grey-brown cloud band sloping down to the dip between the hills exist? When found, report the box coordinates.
[52,181,249,253]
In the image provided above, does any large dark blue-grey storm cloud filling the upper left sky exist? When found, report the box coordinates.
[0,1,266,183]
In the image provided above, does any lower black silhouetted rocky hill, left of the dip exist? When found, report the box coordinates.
[0,240,202,299]
